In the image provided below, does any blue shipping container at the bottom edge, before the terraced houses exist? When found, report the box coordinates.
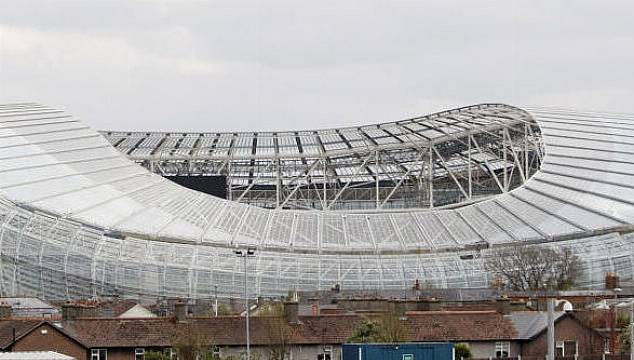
[342,343,454,360]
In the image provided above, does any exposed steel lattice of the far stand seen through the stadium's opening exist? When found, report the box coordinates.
[102,104,541,210]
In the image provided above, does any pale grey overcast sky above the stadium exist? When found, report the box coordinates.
[0,0,634,132]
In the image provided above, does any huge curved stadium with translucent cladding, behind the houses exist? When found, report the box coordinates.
[0,103,634,299]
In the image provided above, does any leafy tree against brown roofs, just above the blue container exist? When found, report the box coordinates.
[348,313,410,343]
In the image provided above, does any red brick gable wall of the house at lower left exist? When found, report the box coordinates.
[12,324,88,360]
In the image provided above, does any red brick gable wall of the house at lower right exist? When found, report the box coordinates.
[522,317,604,359]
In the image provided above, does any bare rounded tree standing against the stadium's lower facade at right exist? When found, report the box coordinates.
[485,244,581,291]
